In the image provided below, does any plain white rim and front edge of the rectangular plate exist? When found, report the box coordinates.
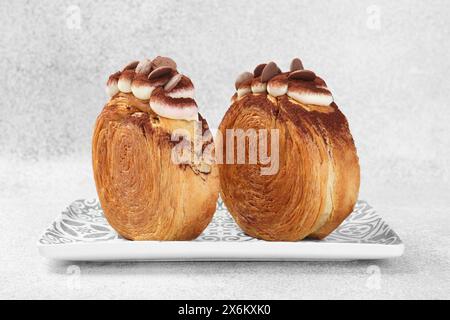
[36,199,405,261]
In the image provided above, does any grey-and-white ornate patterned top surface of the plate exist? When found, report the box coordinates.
[39,199,401,245]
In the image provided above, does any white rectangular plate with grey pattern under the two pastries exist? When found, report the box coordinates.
[38,200,404,261]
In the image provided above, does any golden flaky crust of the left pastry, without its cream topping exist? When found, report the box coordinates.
[92,93,219,240]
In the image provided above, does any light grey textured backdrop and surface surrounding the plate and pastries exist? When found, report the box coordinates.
[0,0,450,298]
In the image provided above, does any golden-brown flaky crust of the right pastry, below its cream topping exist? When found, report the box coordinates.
[219,60,360,241]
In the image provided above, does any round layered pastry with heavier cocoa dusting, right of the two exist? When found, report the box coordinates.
[217,59,360,241]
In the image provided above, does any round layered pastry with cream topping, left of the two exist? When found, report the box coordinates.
[92,57,219,240]
